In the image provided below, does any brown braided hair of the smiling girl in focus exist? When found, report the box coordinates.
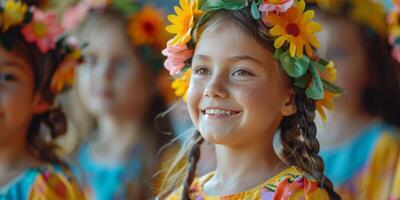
[160,5,341,200]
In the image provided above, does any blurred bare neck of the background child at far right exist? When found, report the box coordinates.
[318,108,379,149]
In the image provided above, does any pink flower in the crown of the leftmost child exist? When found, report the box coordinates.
[22,9,64,53]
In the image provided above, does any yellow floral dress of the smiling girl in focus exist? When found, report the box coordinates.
[167,167,329,200]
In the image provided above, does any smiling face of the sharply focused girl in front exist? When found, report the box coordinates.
[187,20,296,145]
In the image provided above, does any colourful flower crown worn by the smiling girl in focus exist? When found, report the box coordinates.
[163,0,344,120]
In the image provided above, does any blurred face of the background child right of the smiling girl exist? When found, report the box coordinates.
[318,17,368,112]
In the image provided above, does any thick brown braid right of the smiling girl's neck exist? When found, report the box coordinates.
[281,88,341,200]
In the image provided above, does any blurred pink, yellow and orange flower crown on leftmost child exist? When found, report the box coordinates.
[0,0,83,94]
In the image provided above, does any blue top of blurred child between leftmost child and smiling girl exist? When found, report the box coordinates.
[74,144,144,200]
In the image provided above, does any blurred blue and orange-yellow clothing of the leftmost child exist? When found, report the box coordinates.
[0,166,84,200]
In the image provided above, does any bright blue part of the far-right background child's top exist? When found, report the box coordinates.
[320,123,396,186]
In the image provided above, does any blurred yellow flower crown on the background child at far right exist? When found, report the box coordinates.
[306,0,387,37]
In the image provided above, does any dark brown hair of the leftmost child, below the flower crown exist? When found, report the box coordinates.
[12,33,67,167]
